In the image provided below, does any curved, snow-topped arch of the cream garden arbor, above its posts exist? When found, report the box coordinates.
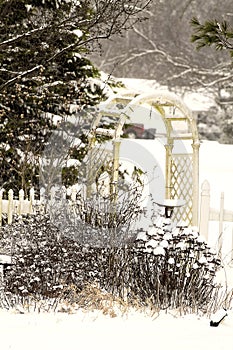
[97,90,199,144]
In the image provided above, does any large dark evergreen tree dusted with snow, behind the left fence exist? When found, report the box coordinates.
[0,0,151,190]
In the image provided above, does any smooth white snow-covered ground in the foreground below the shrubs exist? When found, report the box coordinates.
[0,311,233,350]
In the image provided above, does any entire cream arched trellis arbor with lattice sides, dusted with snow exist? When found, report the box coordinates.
[86,91,200,226]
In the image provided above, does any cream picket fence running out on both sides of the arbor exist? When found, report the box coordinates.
[0,181,233,260]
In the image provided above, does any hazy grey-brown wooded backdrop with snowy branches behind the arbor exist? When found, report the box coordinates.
[91,0,233,143]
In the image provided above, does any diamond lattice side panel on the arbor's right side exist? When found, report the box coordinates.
[170,154,193,224]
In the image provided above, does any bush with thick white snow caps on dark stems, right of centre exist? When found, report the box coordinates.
[137,217,221,309]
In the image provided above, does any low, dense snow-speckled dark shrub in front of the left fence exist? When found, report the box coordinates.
[0,215,98,297]
